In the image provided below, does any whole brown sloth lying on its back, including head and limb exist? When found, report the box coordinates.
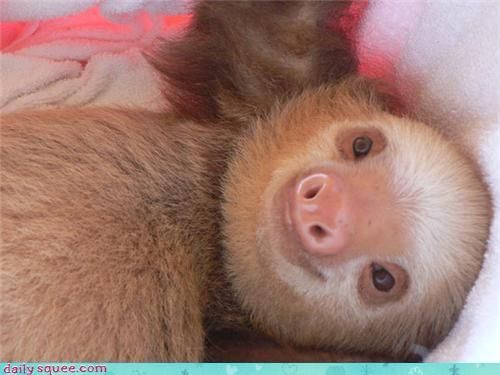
[0,2,489,361]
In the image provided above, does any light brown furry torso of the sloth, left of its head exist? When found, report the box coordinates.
[0,109,241,361]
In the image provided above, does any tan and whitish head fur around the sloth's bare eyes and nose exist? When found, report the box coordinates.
[224,81,490,358]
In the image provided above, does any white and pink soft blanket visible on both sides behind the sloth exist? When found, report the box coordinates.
[0,0,500,362]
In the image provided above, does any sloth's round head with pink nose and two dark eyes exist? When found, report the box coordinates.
[223,82,490,357]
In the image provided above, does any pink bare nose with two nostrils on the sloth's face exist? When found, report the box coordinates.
[289,171,352,255]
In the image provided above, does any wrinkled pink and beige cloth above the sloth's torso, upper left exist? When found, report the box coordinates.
[0,4,188,112]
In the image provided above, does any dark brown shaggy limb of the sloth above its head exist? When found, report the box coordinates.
[146,1,357,121]
